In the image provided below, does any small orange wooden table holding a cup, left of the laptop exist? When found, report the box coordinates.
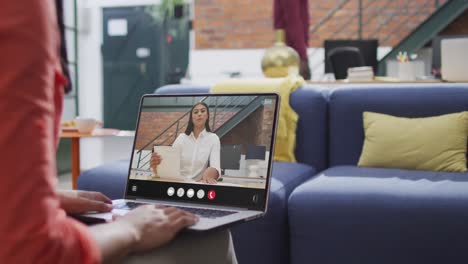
[60,128,121,189]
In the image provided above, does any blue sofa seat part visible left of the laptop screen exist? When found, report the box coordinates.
[77,160,130,199]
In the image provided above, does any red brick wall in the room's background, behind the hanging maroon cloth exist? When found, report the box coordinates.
[194,0,446,49]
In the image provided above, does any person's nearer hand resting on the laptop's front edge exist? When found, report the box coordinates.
[115,205,198,252]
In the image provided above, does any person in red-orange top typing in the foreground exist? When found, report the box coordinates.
[0,0,235,264]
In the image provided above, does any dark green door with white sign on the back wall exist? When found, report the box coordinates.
[102,7,161,130]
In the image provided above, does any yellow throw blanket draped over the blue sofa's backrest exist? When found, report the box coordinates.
[211,76,305,162]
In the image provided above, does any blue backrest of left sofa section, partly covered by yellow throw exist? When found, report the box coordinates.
[155,85,328,171]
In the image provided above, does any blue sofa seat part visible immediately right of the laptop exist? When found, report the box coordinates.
[231,162,315,263]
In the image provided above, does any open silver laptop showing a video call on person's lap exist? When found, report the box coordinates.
[82,93,280,231]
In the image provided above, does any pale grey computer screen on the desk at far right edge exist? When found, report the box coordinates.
[440,38,468,82]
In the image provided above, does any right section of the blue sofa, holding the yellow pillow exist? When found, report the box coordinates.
[288,84,468,264]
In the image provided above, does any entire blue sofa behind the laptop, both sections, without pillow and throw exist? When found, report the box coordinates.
[78,84,468,264]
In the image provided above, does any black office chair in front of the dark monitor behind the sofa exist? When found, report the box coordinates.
[327,47,365,80]
